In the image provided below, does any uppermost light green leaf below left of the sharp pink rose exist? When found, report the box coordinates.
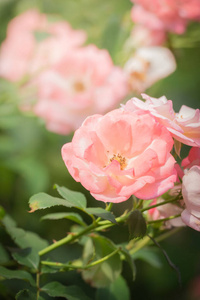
[55,184,87,209]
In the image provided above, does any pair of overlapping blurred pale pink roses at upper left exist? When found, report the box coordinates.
[0,10,128,134]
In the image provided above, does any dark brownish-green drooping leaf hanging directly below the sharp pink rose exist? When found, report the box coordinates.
[127,209,147,239]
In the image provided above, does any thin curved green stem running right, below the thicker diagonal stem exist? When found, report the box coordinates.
[41,248,121,270]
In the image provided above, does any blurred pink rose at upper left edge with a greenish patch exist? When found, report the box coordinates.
[0,10,86,81]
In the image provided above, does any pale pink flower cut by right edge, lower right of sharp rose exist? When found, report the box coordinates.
[181,166,200,231]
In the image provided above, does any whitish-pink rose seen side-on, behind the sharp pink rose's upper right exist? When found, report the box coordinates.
[124,94,200,147]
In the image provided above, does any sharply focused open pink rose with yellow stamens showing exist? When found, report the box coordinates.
[62,109,176,203]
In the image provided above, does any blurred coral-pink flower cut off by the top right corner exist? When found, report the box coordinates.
[131,0,200,34]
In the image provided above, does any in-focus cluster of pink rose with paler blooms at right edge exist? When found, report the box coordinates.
[62,95,200,230]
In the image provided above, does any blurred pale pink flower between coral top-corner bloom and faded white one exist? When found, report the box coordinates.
[127,25,166,48]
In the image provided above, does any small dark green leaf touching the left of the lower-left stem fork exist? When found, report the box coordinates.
[12,248,40,270]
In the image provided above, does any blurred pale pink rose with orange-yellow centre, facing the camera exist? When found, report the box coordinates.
[22,45,128,134]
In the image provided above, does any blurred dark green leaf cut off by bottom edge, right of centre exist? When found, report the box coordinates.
[95,276,130,300]
